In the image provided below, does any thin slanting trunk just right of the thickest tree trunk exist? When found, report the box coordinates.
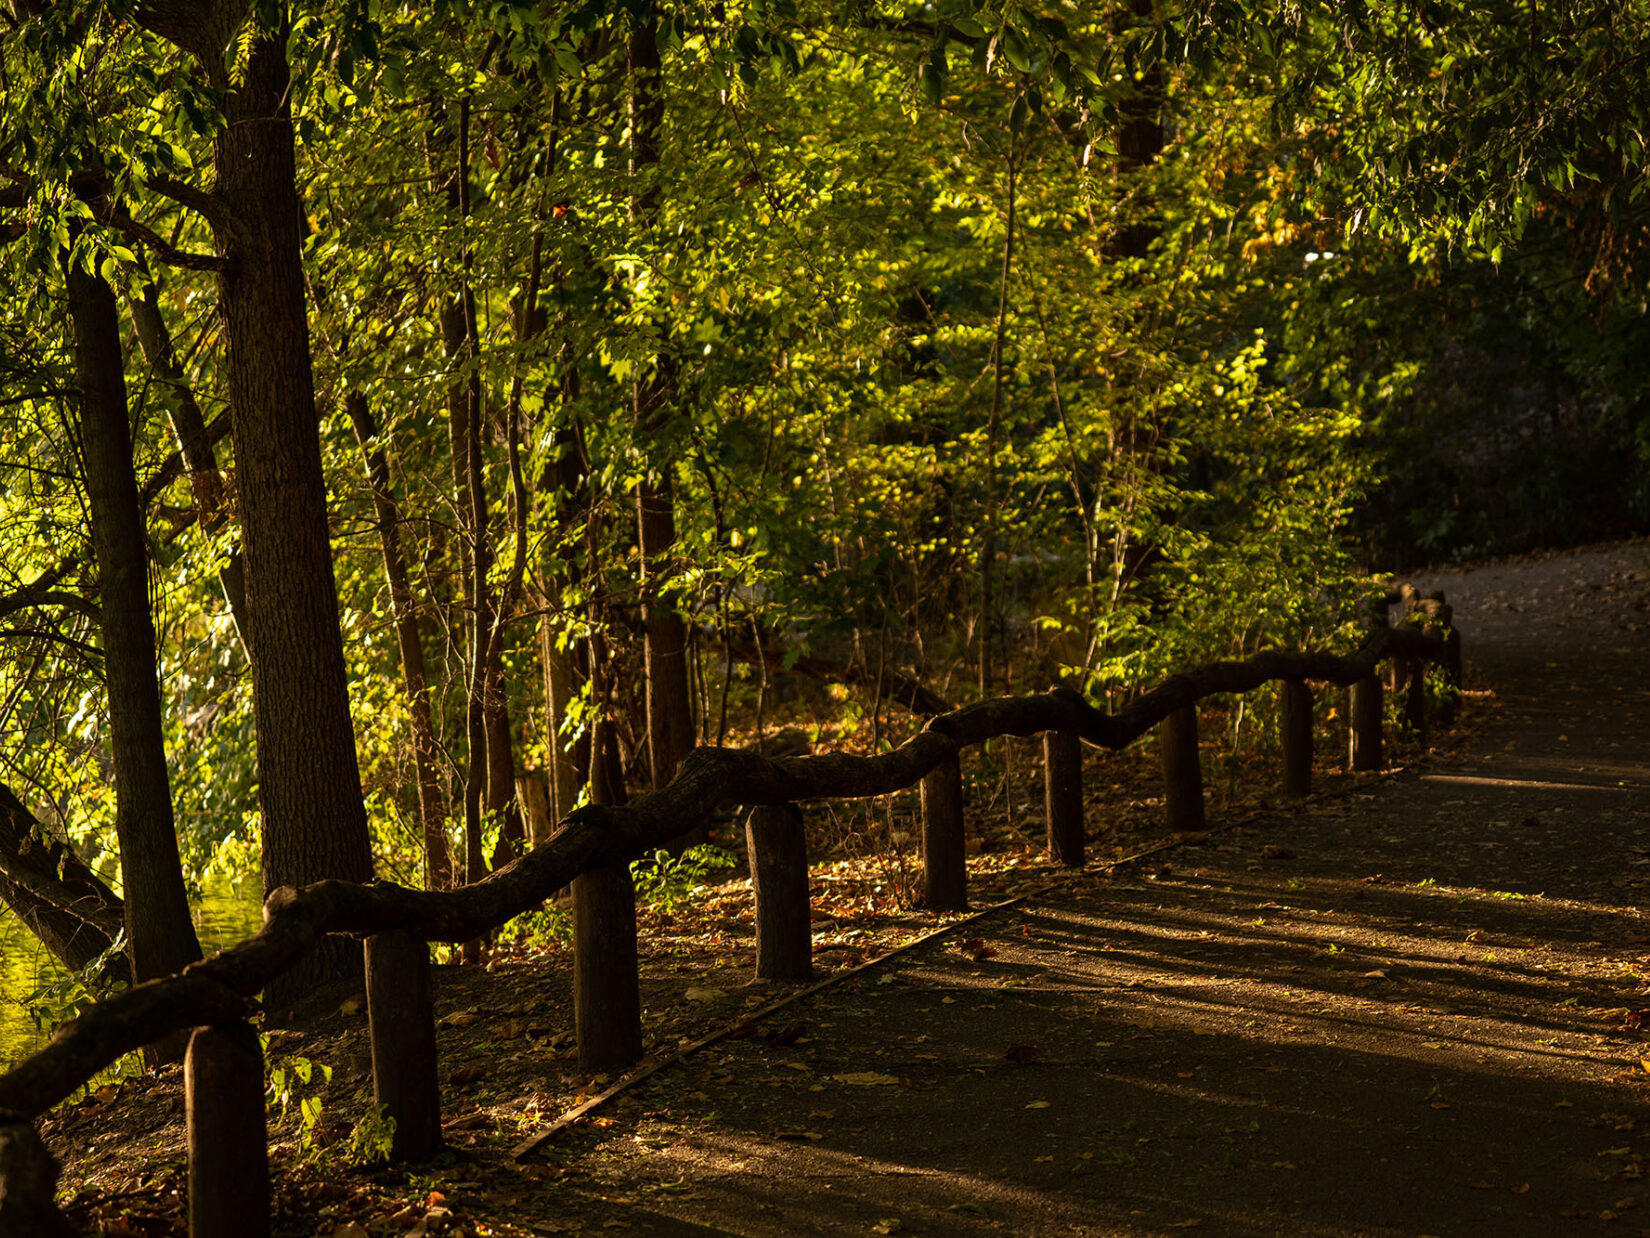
[345,391,454,890]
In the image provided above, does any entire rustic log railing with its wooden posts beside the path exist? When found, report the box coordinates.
[0,589,1460,1238]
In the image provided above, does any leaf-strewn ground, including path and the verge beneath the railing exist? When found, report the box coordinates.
[43,543,1650,1238]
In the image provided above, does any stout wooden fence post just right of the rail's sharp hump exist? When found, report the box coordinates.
[573,862,642,1071]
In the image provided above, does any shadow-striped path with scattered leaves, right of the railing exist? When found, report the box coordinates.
[521,545,1650,1236]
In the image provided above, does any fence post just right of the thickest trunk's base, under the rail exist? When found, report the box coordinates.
[361,929,441,1160]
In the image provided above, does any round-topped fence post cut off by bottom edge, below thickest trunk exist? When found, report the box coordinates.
[183,1022,269,1238]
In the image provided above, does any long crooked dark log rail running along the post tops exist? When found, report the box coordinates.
[0,607,1460,1231]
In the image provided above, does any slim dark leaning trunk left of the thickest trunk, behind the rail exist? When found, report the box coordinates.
[68,267,201,1010]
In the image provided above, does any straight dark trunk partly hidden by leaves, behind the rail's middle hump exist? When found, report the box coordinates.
[627,13,693,787]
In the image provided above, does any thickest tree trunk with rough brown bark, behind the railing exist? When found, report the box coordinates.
[134,21,373,1007]
